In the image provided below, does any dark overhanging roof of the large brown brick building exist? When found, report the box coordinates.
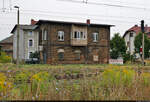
[36,20,114,27]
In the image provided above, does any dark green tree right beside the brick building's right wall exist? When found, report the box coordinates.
[110,33,127,59]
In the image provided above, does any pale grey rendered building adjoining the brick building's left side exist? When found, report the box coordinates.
[11,19,39,61]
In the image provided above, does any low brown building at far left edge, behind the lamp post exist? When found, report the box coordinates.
[0,35,13,57]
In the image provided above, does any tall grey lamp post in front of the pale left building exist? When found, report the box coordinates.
[14,6,20,67]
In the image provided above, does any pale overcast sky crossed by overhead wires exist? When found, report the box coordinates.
[0,0,150,40]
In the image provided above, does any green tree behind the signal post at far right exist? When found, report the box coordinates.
[134,33,150,58]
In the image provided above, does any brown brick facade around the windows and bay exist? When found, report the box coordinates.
[37,21,110,64]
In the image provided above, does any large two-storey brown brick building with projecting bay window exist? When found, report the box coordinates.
[36,20,112,64]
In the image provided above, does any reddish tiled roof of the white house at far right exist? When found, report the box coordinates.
[123,25,150,38]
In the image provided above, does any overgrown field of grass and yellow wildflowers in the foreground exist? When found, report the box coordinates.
[0,64,150,100]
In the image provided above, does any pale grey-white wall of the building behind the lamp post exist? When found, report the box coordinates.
[13,29,39,61]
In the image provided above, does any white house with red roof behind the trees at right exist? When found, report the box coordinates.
[123,25,150,55]
